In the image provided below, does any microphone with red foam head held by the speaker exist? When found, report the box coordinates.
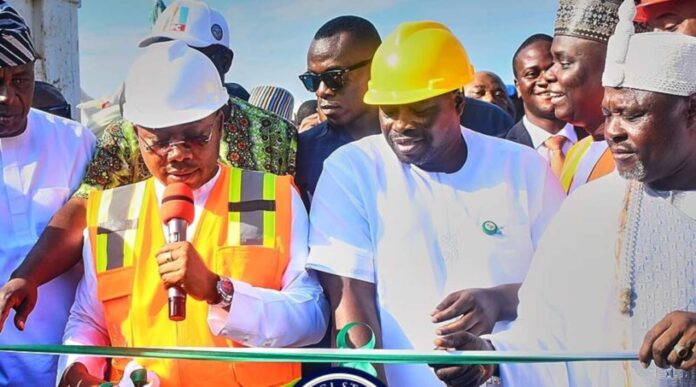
[160,183,195,321]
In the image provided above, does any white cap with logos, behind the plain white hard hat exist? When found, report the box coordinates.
[138,0,230,49]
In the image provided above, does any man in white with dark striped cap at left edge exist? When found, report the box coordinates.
[0,0,95,386]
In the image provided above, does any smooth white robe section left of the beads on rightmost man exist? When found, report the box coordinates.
[491,173,696,387]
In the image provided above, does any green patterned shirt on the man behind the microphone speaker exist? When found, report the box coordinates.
[74,97,297,198]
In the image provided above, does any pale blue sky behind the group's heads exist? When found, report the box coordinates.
[78,0,557,106]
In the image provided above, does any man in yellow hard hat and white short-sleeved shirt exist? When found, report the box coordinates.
[307,21,564,386]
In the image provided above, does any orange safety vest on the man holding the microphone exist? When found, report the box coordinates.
[87,166,300,386]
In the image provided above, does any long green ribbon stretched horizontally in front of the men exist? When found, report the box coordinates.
[0,345,638,364]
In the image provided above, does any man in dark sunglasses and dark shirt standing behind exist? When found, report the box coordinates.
[296,16,381,207]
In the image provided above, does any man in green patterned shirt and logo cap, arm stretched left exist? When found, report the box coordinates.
[0,0,297,346]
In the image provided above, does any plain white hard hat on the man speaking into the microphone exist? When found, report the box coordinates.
[123,41,229,129]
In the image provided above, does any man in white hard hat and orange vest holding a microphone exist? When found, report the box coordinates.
[59,42,328,386]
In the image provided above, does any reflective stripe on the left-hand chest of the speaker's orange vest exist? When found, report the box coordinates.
[95,182,145,273]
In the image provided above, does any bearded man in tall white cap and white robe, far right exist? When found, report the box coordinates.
[432,0,696,387]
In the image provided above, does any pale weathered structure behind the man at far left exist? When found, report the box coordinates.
[6,0,81,119]
